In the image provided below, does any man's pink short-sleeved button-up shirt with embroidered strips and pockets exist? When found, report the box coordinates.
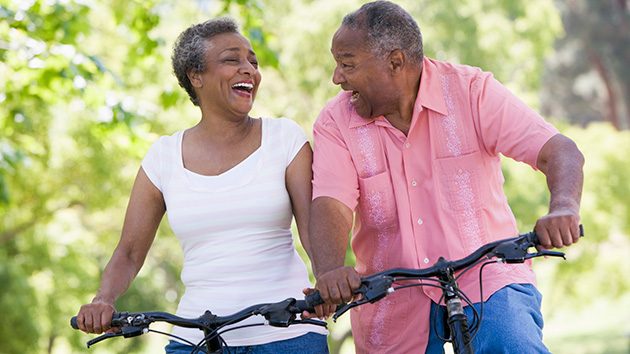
[313,58,557,353]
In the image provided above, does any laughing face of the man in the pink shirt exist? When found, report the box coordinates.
[331,26,395,118]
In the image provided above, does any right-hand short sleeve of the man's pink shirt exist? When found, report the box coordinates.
[472,73,558,169]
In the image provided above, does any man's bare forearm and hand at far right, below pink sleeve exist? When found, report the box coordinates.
[534,134,584,248]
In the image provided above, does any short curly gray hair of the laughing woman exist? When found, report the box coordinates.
[171,17,239,106]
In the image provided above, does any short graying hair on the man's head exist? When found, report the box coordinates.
[341,1,424,64]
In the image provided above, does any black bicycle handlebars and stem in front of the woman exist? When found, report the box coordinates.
[70,294,327,354]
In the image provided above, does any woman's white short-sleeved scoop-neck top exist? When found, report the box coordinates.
[142,118,327,346]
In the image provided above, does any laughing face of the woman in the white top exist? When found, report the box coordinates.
[193,33,262,116]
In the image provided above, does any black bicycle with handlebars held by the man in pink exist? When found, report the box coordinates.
[312,225,584,354]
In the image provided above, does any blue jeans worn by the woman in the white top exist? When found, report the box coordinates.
[164,332,328,354]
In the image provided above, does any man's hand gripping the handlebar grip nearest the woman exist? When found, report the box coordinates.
[315,267,361,312]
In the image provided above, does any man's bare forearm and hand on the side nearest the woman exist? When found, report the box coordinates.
[309,197,361,308]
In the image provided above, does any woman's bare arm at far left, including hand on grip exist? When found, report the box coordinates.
[77,168,166,333]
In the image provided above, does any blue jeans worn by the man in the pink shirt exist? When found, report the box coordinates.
[426,284,549,354]
